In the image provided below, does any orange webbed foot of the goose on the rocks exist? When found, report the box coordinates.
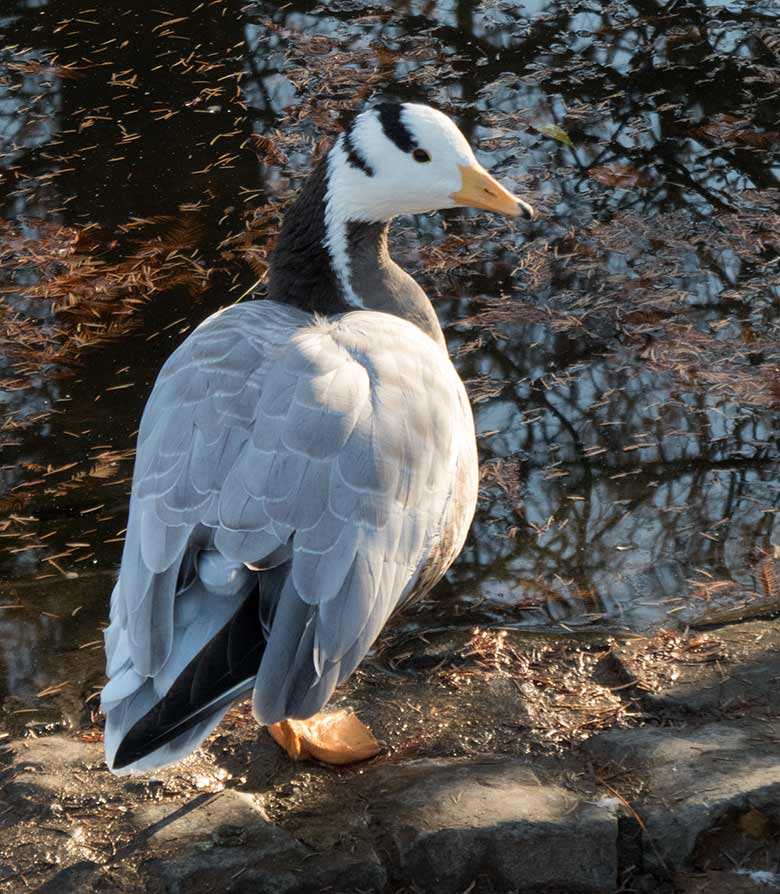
[268,711,382,764]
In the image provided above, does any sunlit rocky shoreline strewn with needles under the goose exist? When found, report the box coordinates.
[0,621,780,894]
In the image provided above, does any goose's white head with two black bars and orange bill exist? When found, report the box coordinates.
[328,103,533,222]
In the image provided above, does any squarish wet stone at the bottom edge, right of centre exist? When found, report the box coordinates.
[370,759,618,894]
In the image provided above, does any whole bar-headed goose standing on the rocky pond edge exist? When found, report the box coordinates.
[102,103,532,773]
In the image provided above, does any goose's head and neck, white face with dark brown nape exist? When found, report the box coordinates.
[268,103,533,340]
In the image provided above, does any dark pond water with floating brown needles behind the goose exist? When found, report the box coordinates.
[0,0,780,719]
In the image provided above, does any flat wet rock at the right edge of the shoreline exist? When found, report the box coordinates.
[585,720,780,874]
